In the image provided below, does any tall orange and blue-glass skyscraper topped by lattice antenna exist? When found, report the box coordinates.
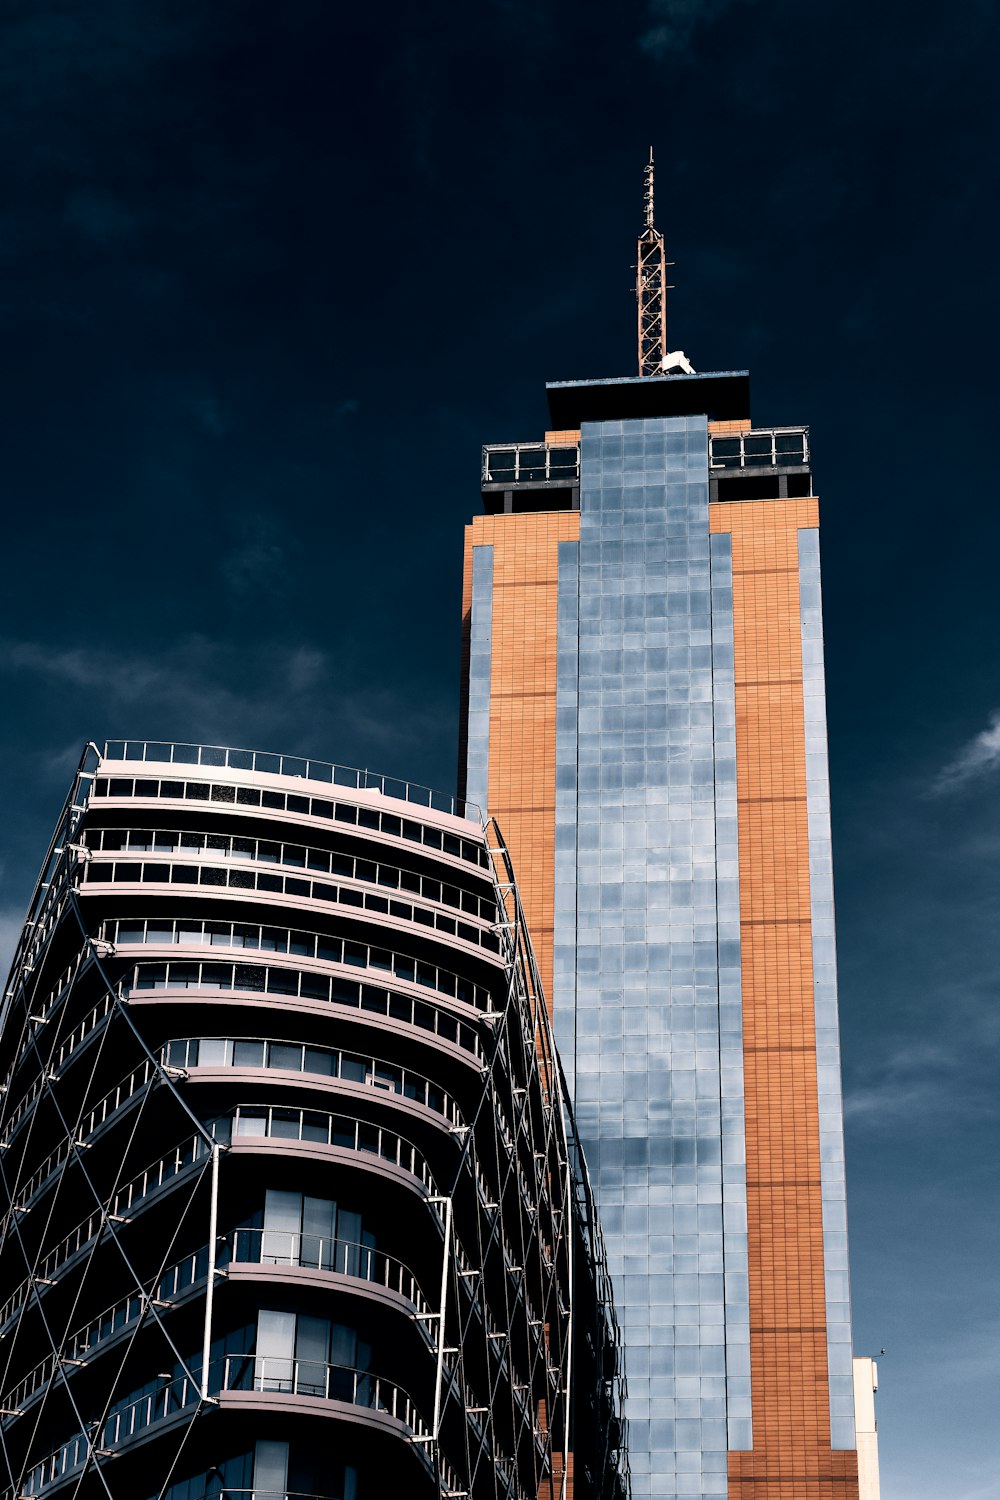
[460,162,881,1500]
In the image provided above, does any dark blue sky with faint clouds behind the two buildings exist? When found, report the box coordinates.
[0,0,1000,1500]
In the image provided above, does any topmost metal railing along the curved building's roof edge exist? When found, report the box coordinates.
[99,740,483,822]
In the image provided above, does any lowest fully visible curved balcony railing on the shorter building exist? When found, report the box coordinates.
[21,1355,430,1496]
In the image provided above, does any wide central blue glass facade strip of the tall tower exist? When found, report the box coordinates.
[553,417,751,1497]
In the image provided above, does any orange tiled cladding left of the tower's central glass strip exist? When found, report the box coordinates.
[465,510,580,1014]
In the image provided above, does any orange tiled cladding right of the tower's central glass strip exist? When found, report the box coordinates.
[709,498,858,1500]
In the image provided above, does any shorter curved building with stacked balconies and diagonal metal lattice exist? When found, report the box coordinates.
[0,741,628,1500]
